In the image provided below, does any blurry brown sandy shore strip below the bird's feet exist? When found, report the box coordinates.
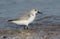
[0,30,60,39]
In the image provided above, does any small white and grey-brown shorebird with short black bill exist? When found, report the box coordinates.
[8,9,42,29]
